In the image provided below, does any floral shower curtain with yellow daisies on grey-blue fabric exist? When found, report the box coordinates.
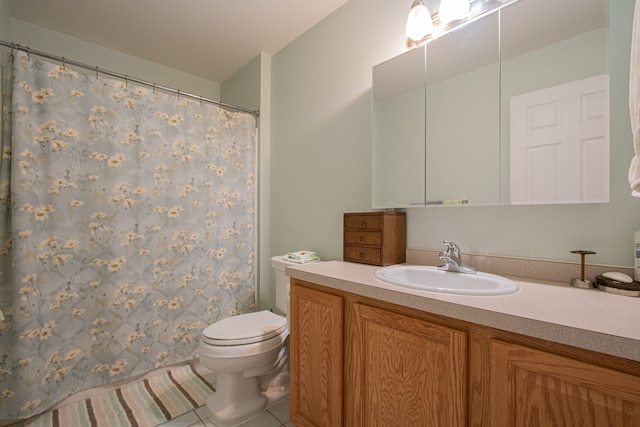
[0,52,257,419]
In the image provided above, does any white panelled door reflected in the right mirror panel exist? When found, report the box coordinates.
[510,75,609,205]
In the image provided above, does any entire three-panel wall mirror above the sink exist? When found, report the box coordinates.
[372,0,609,208]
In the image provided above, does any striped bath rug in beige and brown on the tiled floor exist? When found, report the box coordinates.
[25,365,213,427]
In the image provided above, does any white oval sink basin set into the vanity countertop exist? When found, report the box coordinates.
[374,265,520,295]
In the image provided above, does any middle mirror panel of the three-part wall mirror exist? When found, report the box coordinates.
[426,13,500,205]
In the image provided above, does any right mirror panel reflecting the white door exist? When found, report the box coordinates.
[501,0,609,204]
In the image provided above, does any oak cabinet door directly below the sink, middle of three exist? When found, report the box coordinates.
[347,304,467,427]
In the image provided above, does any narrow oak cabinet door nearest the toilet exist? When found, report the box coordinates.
[289,284,343,427]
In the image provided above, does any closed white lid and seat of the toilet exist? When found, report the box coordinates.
[202,310,287,345]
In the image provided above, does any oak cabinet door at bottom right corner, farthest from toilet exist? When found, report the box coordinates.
[490,341,640,427]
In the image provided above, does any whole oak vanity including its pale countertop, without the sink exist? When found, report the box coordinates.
[286,261,640,427]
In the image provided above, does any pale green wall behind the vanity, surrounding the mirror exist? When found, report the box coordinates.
[270,0,640,267]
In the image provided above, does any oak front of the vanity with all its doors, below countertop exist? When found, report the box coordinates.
[290,279,640,427]
